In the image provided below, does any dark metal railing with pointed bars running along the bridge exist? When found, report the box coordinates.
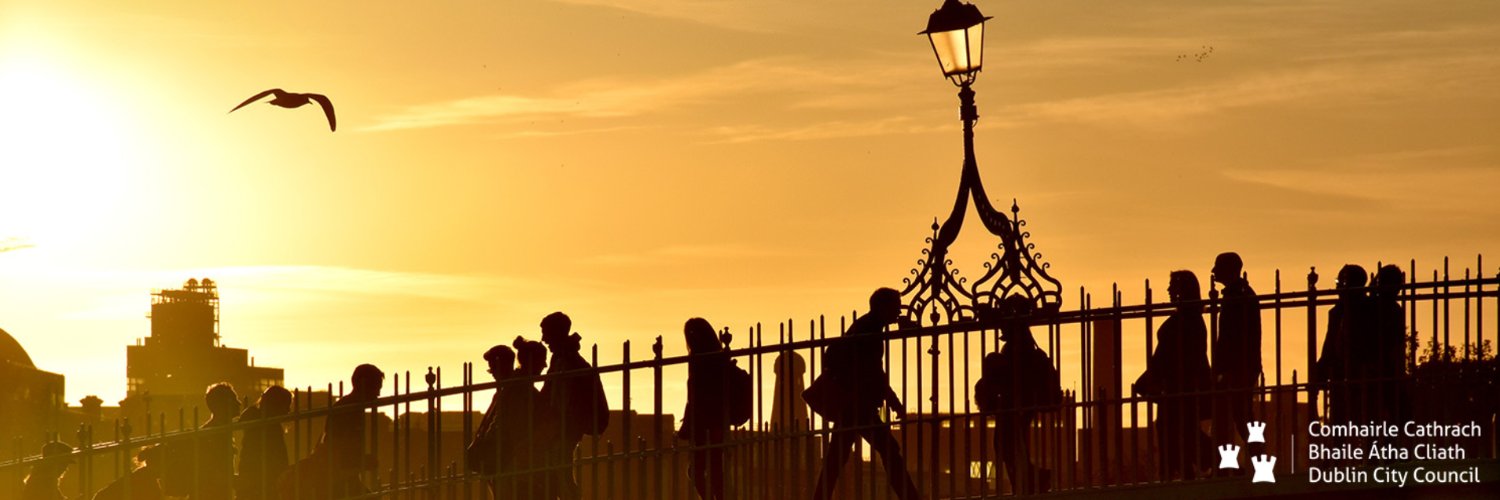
[0,255,1500,498]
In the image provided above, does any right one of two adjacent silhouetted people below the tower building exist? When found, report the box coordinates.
[236,386,291,500]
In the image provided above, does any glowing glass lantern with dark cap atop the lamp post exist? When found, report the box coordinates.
[921,0,990,86]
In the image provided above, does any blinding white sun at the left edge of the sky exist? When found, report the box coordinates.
[0,54,138,246]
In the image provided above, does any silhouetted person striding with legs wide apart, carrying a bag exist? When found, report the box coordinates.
[809,288,921,500]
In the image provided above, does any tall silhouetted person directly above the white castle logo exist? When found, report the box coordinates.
[1212,252,1262,453]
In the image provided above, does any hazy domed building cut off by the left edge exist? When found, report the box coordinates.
[0,325,66,450]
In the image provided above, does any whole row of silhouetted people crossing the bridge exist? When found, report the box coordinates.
[14,252,1410,500]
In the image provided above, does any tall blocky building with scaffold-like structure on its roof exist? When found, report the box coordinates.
[125,278,282,414]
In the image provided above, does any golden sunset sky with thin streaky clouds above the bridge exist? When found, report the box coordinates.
[0,0,1500,402]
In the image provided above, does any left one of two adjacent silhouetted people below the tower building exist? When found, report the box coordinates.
[189,383,240,500]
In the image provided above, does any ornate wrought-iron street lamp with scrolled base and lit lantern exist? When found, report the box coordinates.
[902,0,1062,324]
